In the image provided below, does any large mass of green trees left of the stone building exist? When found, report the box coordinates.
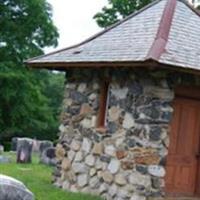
[0,0,64,145]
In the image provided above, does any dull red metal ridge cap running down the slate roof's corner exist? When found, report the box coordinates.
[146,0,177,61]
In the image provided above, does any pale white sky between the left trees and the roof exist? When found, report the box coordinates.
[45,0,107,53]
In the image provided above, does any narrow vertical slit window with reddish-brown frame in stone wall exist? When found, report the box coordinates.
[97,81,109,132]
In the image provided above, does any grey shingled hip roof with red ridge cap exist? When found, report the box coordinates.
[26,0,200,70]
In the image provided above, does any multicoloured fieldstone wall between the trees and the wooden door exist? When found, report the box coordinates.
[54,69,177,200]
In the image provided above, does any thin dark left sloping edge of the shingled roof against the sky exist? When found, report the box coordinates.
[25,0,162,63]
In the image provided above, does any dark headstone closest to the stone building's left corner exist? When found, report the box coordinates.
[40,147,56,166]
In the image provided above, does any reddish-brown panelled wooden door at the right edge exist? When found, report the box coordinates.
[165,98,200,196]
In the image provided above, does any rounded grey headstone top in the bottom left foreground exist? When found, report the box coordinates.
[0,175,35,200]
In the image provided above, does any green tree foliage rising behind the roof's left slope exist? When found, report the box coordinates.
[94,0,152,28]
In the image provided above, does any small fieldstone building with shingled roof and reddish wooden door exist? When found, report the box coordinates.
[27,0,200,200]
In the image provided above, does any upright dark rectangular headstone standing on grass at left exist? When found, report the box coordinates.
[17,138,33,163]
